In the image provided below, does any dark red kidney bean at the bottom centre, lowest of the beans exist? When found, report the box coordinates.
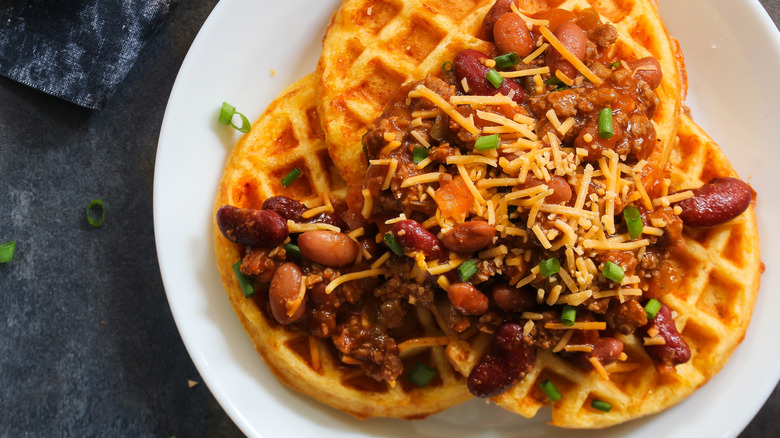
[468,322,536,398]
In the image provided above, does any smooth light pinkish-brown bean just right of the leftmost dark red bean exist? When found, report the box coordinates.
[298,230,359,268]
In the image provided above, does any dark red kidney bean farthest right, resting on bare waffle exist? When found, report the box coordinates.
[677,178,753,227]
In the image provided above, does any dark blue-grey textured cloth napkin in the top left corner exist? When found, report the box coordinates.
[0,0,178,109]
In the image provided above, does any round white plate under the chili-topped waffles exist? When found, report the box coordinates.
[154,0,780,438]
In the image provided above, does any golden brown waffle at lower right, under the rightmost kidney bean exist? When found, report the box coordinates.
[484,116,761,428]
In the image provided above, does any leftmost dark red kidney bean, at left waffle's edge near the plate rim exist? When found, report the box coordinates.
[217,205,289,248]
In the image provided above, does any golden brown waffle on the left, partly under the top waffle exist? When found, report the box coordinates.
[214,75,471,418]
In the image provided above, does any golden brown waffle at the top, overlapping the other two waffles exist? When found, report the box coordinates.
[317,0,684,184]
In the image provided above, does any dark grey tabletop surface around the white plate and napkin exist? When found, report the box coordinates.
[0,0,780,438]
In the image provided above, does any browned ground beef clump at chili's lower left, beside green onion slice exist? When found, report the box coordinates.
[333,313,403,381]
